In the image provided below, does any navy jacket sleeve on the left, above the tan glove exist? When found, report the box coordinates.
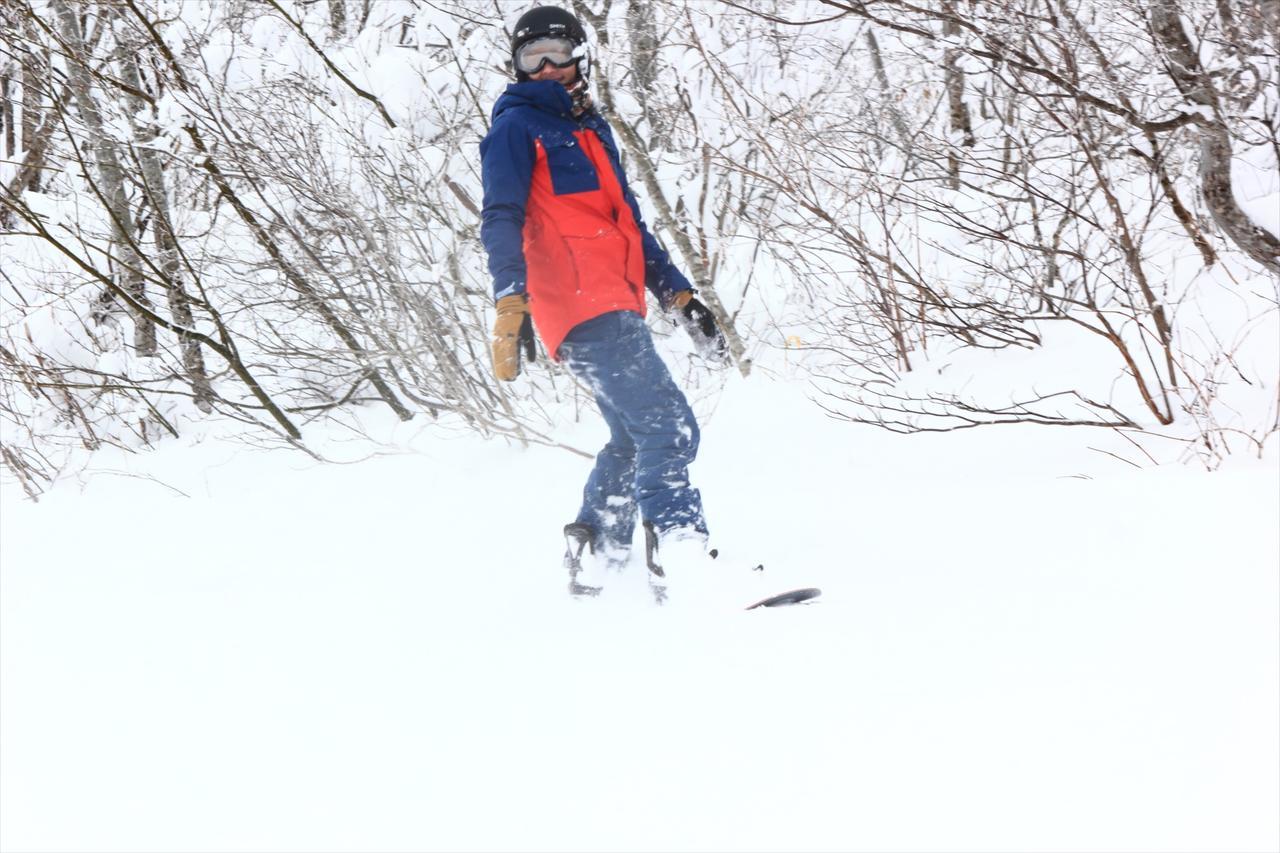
[480,112,538,300]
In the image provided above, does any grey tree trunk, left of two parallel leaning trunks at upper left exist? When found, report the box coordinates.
[52,0,156,357]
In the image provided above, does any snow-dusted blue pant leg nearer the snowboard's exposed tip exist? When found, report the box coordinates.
[561,311,707,533]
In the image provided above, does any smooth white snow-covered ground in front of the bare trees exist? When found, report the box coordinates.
[0,379,1280,850]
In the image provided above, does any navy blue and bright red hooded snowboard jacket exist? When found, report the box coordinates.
[480,81,690,359]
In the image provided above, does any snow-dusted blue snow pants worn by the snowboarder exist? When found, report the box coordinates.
[559,311,707,549]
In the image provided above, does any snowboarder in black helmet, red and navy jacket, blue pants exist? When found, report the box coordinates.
[480,6,727,591]
